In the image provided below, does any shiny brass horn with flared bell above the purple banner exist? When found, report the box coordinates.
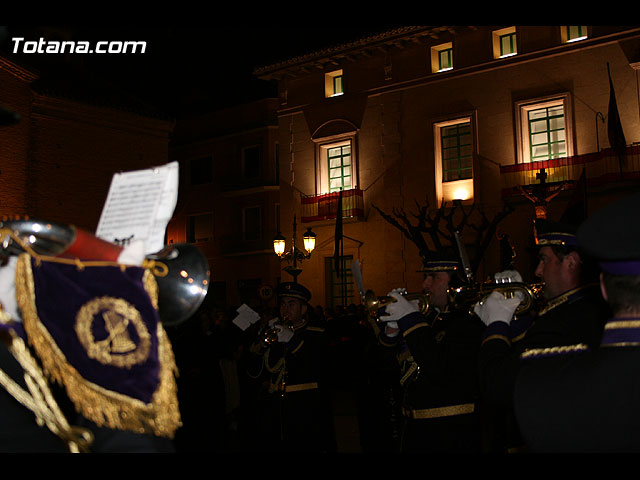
[0,218,210,326]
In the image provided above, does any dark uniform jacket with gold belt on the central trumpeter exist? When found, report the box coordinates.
[383,309,484,453]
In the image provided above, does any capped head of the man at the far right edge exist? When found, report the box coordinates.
[578,193,640,317]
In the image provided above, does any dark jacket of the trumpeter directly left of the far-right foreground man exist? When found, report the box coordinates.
[480,285,609,450]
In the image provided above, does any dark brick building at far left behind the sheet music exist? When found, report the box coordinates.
[0,57,174,232]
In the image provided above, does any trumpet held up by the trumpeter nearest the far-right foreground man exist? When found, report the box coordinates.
[448,282,544,315]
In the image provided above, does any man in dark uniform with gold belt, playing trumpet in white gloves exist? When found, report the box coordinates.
[380,254,484,453]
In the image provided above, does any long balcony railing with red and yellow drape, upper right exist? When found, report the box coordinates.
[500,145,640,197]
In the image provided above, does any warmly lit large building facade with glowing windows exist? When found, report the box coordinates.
[255,26,640,305]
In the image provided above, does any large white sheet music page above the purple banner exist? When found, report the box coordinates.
[96,162,178,254]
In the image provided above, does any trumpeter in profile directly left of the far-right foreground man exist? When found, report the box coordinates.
[474,220,608,452]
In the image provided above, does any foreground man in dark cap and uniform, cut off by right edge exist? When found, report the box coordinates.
[514,194,640,452]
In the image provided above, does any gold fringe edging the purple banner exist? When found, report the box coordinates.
[16,253,182,438]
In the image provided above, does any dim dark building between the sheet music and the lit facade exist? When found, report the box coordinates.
[167,98,280,310]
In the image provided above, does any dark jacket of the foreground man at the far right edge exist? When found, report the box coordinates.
[514,318,640,452]
